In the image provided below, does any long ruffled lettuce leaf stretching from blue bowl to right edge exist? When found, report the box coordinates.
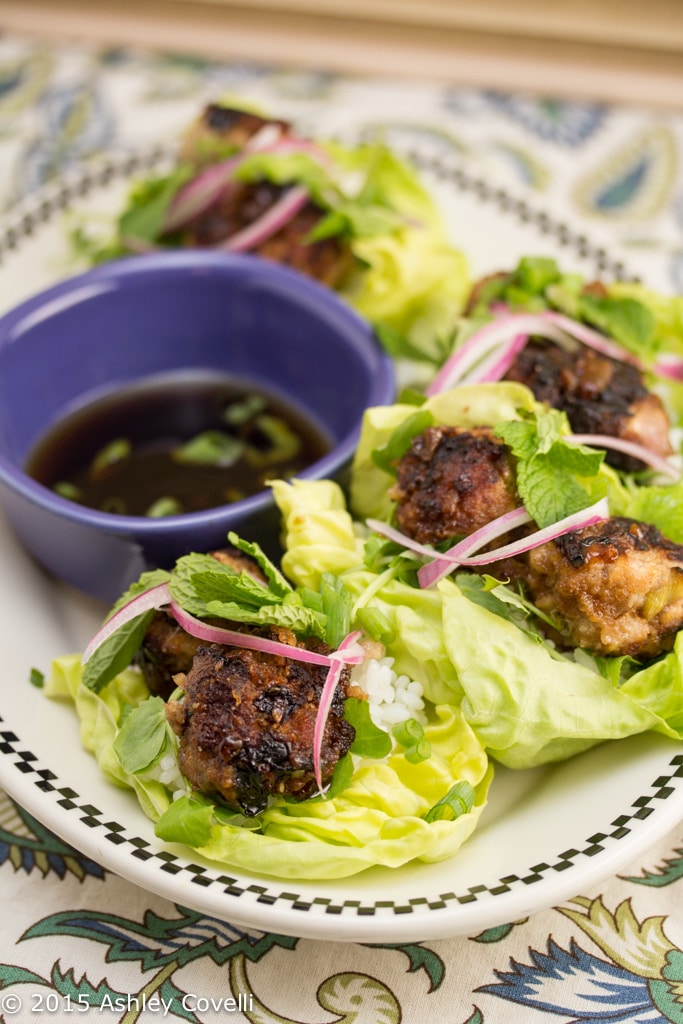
[275,471,683,768]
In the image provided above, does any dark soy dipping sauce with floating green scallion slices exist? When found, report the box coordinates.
[27,374,331,516]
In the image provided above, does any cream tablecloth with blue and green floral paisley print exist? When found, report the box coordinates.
[0,29,683,1024]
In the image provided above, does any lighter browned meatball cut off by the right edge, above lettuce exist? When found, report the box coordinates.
[526,516,683,658]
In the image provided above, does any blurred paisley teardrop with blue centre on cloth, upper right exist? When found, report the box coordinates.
[573,124,678,221]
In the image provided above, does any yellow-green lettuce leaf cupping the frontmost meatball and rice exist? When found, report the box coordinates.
[46,655,493,880]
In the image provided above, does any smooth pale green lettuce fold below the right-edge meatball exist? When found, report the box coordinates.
[439,581,683,768]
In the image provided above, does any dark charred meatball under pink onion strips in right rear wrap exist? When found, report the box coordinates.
[506,339,672,472]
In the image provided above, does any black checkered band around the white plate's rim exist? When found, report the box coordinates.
[0,140,655,918]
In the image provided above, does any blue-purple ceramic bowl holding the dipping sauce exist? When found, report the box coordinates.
[0,251,394,602]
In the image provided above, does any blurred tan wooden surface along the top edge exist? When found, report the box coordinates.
[0,0,683,110]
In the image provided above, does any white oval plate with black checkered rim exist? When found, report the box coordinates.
[0,154,683,942]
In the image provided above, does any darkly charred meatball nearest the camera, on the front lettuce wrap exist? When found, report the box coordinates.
[167,628,355,815]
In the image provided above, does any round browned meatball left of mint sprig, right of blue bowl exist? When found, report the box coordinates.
[389,426,519,544]
